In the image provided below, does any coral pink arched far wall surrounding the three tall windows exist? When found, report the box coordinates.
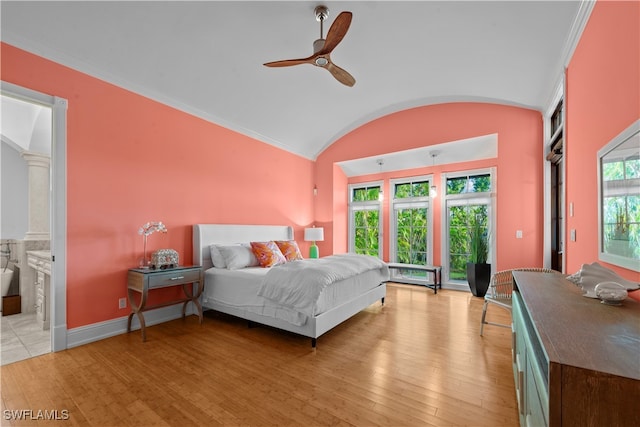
[316,103,543,270]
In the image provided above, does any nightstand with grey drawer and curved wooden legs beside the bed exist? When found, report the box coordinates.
[127,265,204,342]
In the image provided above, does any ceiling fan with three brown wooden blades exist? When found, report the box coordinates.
[264,6,356,86]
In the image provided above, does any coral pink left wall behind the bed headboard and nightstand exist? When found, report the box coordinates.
[1,43,313,328]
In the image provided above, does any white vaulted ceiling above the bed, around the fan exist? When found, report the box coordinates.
[0,0,584,171]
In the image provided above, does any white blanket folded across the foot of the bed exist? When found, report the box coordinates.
[258,254,389,316]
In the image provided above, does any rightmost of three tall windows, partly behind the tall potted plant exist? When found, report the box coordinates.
[443,171,494,282]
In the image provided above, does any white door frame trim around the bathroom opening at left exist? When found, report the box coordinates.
[0,81,67,351]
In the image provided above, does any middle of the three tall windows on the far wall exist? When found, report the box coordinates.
[390,177,433,282]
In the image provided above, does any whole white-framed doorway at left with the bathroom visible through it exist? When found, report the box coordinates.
[0,82,67,365]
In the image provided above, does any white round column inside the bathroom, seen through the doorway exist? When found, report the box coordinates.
[22,151,51,240]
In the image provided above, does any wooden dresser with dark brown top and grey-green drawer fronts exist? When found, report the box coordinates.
[513,271,640,427]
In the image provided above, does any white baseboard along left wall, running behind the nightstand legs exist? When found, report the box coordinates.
[66,304,197,349]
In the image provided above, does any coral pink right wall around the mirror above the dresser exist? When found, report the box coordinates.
[565,1,640,299]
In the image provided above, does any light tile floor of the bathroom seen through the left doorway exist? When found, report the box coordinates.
[0,313,51,365]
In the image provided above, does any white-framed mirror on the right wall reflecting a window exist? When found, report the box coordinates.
[598,120,640,271]
